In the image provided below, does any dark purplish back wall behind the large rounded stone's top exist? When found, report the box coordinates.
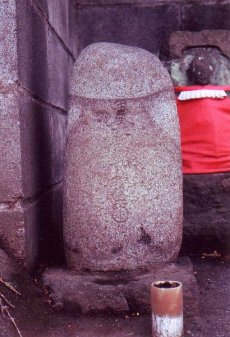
[75,0,230,55]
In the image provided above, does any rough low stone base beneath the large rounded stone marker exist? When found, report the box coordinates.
[43,258,199,317]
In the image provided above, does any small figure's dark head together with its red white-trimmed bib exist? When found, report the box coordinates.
[176,48,230,174]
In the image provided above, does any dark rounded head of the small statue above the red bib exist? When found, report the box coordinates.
[188,52,215,85]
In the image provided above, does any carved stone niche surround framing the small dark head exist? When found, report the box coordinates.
[169,29,230,86]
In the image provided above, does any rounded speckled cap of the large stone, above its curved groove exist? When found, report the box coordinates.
[70,42,172,99]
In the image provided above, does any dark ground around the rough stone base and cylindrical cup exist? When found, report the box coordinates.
[0,256,230,337]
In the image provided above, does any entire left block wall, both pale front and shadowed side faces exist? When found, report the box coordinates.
[0,0,77,268]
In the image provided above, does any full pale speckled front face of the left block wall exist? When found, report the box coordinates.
[0,0,25,259]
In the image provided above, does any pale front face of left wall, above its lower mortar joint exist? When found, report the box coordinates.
[0,1,22,201]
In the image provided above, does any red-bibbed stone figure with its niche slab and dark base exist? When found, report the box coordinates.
[167,30,230,255]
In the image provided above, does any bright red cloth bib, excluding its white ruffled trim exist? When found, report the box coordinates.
[175,85,230,174]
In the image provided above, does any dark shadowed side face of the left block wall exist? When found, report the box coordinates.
[17,0,77,267]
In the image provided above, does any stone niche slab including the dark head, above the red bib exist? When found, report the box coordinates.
[168,30,230,86]
